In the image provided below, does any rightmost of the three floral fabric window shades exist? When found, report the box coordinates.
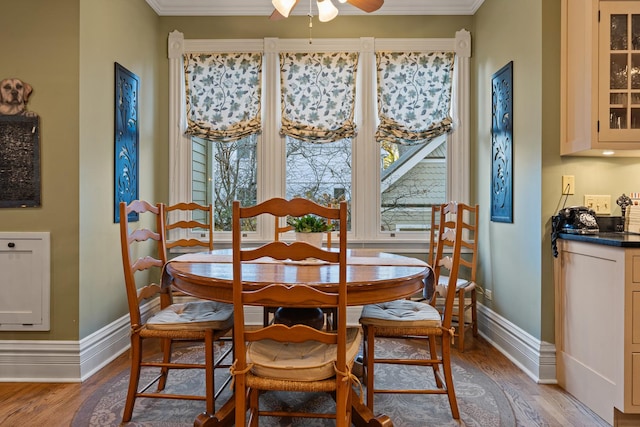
[376,52,455,145]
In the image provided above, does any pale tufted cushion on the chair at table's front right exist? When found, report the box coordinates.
[360,299,442,328]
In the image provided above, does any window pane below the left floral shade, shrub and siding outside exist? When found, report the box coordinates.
[192,135,257,231]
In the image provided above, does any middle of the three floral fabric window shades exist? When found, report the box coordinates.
[280,53,358,143]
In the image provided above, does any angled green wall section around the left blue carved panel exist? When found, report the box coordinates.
[79,0,169,337]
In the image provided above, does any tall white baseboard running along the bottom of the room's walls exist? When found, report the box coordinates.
[0,304,557,384]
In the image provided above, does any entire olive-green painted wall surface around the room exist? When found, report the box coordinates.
[6,0,624,348]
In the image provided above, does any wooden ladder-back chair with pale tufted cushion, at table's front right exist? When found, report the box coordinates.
[360,203,463,419]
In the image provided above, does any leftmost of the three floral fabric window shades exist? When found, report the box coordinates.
[184,53,262,142]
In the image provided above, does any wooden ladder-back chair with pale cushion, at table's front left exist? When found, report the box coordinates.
[119,200,233,422]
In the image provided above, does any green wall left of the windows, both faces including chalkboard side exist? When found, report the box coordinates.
[0,0,168,340]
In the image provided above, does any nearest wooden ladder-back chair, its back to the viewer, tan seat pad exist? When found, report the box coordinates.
[232,198,361,427]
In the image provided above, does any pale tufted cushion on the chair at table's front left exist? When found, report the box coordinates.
[147,301,233,330]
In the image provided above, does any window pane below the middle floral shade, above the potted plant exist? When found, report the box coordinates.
[286,137,351,229]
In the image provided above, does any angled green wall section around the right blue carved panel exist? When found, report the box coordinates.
[472,0,544,339]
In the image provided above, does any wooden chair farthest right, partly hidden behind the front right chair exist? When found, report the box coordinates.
[428,203,479,351]
